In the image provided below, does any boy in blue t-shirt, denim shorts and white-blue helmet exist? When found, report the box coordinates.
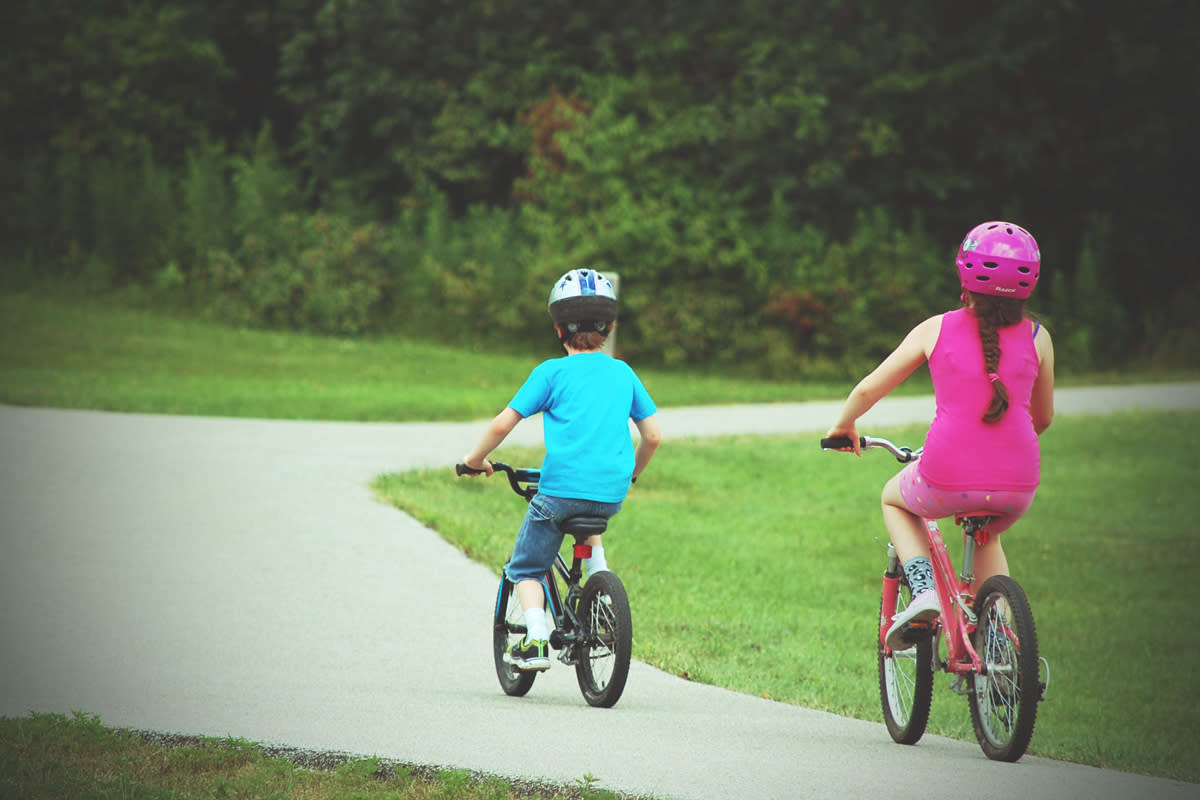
[462,270,661,670]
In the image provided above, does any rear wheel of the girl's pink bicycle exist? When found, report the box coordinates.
[968,575,1042,762]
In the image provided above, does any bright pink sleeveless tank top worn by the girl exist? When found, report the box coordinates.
[918,308,1042,492]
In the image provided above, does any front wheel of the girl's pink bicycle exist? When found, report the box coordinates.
[875,578,934,745]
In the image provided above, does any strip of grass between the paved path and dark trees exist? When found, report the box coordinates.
[0,289,1200,421]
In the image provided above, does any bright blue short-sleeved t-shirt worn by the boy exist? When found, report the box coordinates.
[509,353,658,503]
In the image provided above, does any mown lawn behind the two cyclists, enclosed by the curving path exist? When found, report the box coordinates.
[376,413,1200,781]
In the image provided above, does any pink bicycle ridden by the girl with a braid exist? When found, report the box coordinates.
[821,437,1050,762]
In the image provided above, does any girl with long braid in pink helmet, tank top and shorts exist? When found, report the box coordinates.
[828,222,1054,649]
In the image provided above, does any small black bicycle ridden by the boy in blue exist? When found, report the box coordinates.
[455,462,634,708]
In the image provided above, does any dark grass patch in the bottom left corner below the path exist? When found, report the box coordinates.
[0,712,648,800]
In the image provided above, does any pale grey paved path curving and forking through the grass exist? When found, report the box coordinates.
[0,384,1200,800]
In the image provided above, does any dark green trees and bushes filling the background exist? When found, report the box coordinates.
[0,0,1200,374]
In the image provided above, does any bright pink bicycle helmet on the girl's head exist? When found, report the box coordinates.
[956,221,1042,300]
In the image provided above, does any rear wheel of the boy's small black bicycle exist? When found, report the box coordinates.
[575,572,634,708]
